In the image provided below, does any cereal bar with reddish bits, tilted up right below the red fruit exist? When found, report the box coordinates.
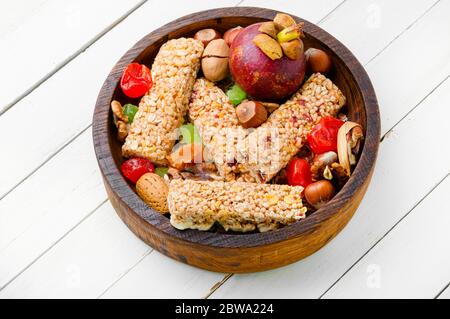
[239,73,345,183]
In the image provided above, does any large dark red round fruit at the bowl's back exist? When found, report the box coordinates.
[230,23,306,101]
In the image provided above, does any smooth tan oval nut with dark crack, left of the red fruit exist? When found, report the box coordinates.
[202,39,230,82]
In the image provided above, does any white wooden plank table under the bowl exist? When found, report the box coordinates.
[0,0,450,298]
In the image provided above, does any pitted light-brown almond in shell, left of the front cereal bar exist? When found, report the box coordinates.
[136,173,169,214]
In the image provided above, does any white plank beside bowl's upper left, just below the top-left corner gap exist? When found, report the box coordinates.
[0,0,238,198]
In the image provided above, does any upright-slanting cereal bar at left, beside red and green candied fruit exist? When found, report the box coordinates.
[122,38,203,165]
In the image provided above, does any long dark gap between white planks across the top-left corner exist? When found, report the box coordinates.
[0,0,148,117]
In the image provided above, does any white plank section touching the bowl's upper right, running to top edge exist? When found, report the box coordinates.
[320,0,437,64]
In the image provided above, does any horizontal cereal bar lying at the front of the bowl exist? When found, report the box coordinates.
[167,179,307,232]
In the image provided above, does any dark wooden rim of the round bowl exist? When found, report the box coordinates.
[93,7,380,248]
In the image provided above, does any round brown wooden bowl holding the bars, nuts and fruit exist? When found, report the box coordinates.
[93,7,380,273]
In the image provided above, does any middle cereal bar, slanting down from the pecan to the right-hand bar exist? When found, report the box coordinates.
[188,78,247,181]
